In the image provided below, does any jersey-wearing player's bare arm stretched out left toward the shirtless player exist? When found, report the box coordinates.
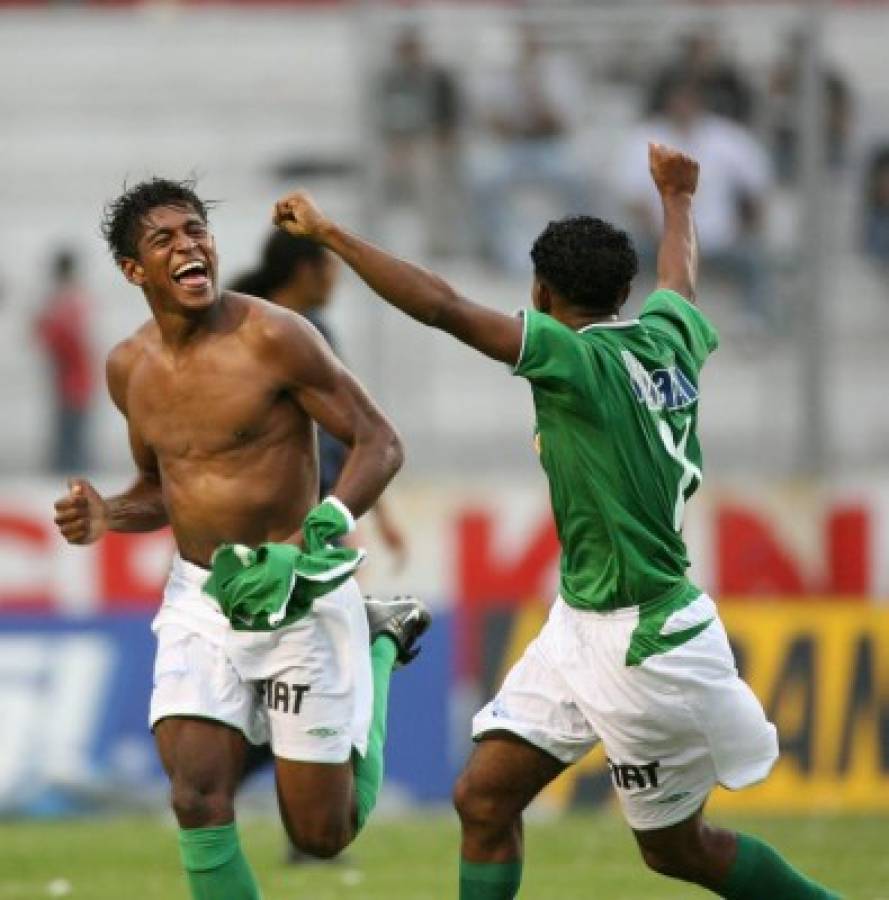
[275,193,522,365]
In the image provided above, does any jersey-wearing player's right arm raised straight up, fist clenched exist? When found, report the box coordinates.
[648,144,699,302]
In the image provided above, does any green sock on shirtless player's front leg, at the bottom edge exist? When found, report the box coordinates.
[179,822,262,900]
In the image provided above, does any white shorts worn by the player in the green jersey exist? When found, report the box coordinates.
[472,595,778,831]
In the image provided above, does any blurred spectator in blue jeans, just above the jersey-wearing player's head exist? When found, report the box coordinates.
[476,27,590,270]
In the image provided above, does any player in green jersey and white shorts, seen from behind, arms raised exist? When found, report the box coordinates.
[275,145,834,900]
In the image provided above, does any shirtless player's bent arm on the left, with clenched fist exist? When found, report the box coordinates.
[55,343,168,544]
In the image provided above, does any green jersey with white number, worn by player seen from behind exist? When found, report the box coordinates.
[515,290,719,612]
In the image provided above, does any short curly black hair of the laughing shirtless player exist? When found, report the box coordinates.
[101,178,213,262]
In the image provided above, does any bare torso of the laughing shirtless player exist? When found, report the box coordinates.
[119,294,318,566]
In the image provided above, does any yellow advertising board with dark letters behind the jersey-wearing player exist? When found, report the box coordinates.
[496,598,889,813]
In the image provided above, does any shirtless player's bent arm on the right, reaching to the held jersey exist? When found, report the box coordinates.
[267,309,404,518]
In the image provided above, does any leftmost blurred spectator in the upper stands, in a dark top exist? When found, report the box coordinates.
[377,29,463,256]
